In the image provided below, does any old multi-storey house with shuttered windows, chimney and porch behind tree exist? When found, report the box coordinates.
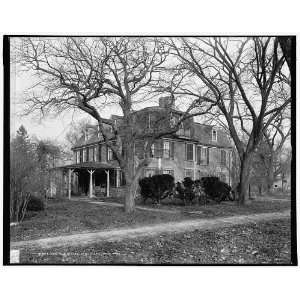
[51,97,232,197]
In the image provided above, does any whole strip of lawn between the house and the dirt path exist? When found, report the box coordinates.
[11,200,290,241]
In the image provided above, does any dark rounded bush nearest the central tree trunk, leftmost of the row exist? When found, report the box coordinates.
[139,174,175,203]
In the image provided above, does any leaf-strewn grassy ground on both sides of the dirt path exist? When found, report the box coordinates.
[11,199,291,264]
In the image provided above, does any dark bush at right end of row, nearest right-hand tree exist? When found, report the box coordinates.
[200,177,232,202]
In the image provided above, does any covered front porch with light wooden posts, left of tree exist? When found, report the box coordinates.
[50,162,125,199]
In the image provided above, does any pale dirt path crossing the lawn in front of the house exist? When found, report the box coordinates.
[11,211,290,249]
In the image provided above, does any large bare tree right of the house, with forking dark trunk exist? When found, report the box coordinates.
[170,37,291,204]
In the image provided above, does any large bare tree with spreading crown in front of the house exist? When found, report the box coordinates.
[17,37,210,212]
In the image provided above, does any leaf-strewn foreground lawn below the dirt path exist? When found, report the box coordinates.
[20,219,291,264]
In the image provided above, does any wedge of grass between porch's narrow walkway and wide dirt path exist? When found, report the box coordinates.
[10,200,195,241]
